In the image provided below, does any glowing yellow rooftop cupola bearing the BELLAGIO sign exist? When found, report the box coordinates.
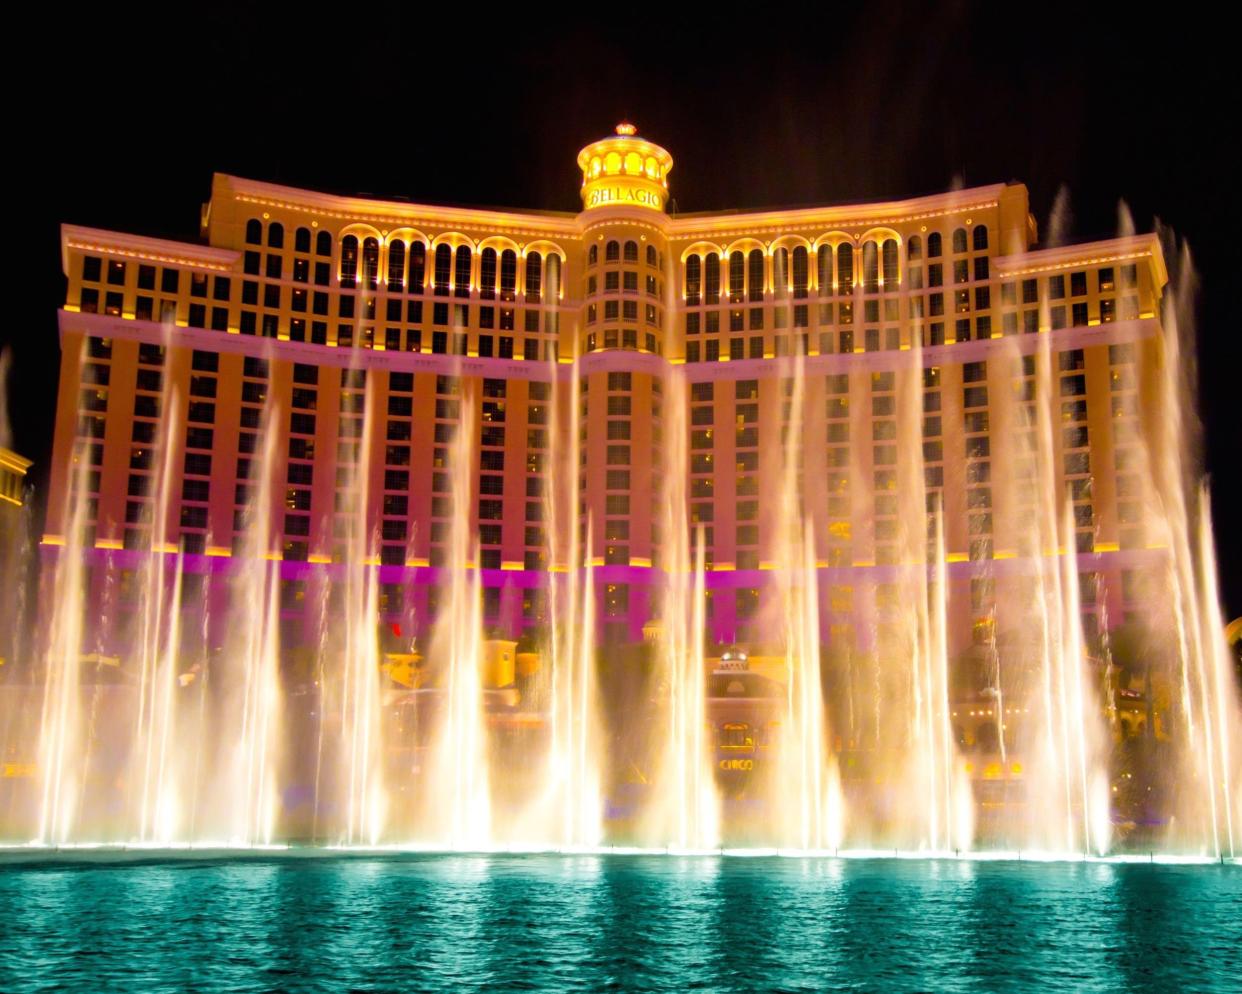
[578,122,673,211]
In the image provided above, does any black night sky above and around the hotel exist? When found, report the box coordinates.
[12,2,1242,616]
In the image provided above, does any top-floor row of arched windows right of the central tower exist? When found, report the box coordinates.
[684,225,987,307]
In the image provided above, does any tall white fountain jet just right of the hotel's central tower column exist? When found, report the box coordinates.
[653,370,720,849]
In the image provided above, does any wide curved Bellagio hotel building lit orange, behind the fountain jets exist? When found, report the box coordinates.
[43,124,1166,646]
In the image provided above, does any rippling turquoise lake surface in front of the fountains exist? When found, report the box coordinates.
[0,855,1242,994]
